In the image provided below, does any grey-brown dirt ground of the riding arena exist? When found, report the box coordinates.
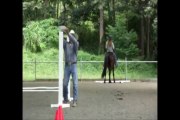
[23,81,157,120]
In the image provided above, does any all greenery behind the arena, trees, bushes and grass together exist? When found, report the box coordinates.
[23,0,157,79]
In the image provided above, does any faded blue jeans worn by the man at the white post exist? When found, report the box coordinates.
[63,64,78,101]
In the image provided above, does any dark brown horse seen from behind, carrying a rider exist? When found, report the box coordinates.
[101,52,115,83]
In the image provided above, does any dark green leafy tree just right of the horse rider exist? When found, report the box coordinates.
[107,14,139,59]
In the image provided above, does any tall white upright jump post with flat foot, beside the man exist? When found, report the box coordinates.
[51,31,70,108]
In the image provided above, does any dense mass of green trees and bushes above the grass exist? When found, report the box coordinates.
[23,0,157,60]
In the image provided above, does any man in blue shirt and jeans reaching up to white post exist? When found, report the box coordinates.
[63,27,79,107]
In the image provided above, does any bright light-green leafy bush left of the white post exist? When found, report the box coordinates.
[23,18,58,52]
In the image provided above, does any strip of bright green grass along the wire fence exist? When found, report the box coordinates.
[23,49,157,81]
